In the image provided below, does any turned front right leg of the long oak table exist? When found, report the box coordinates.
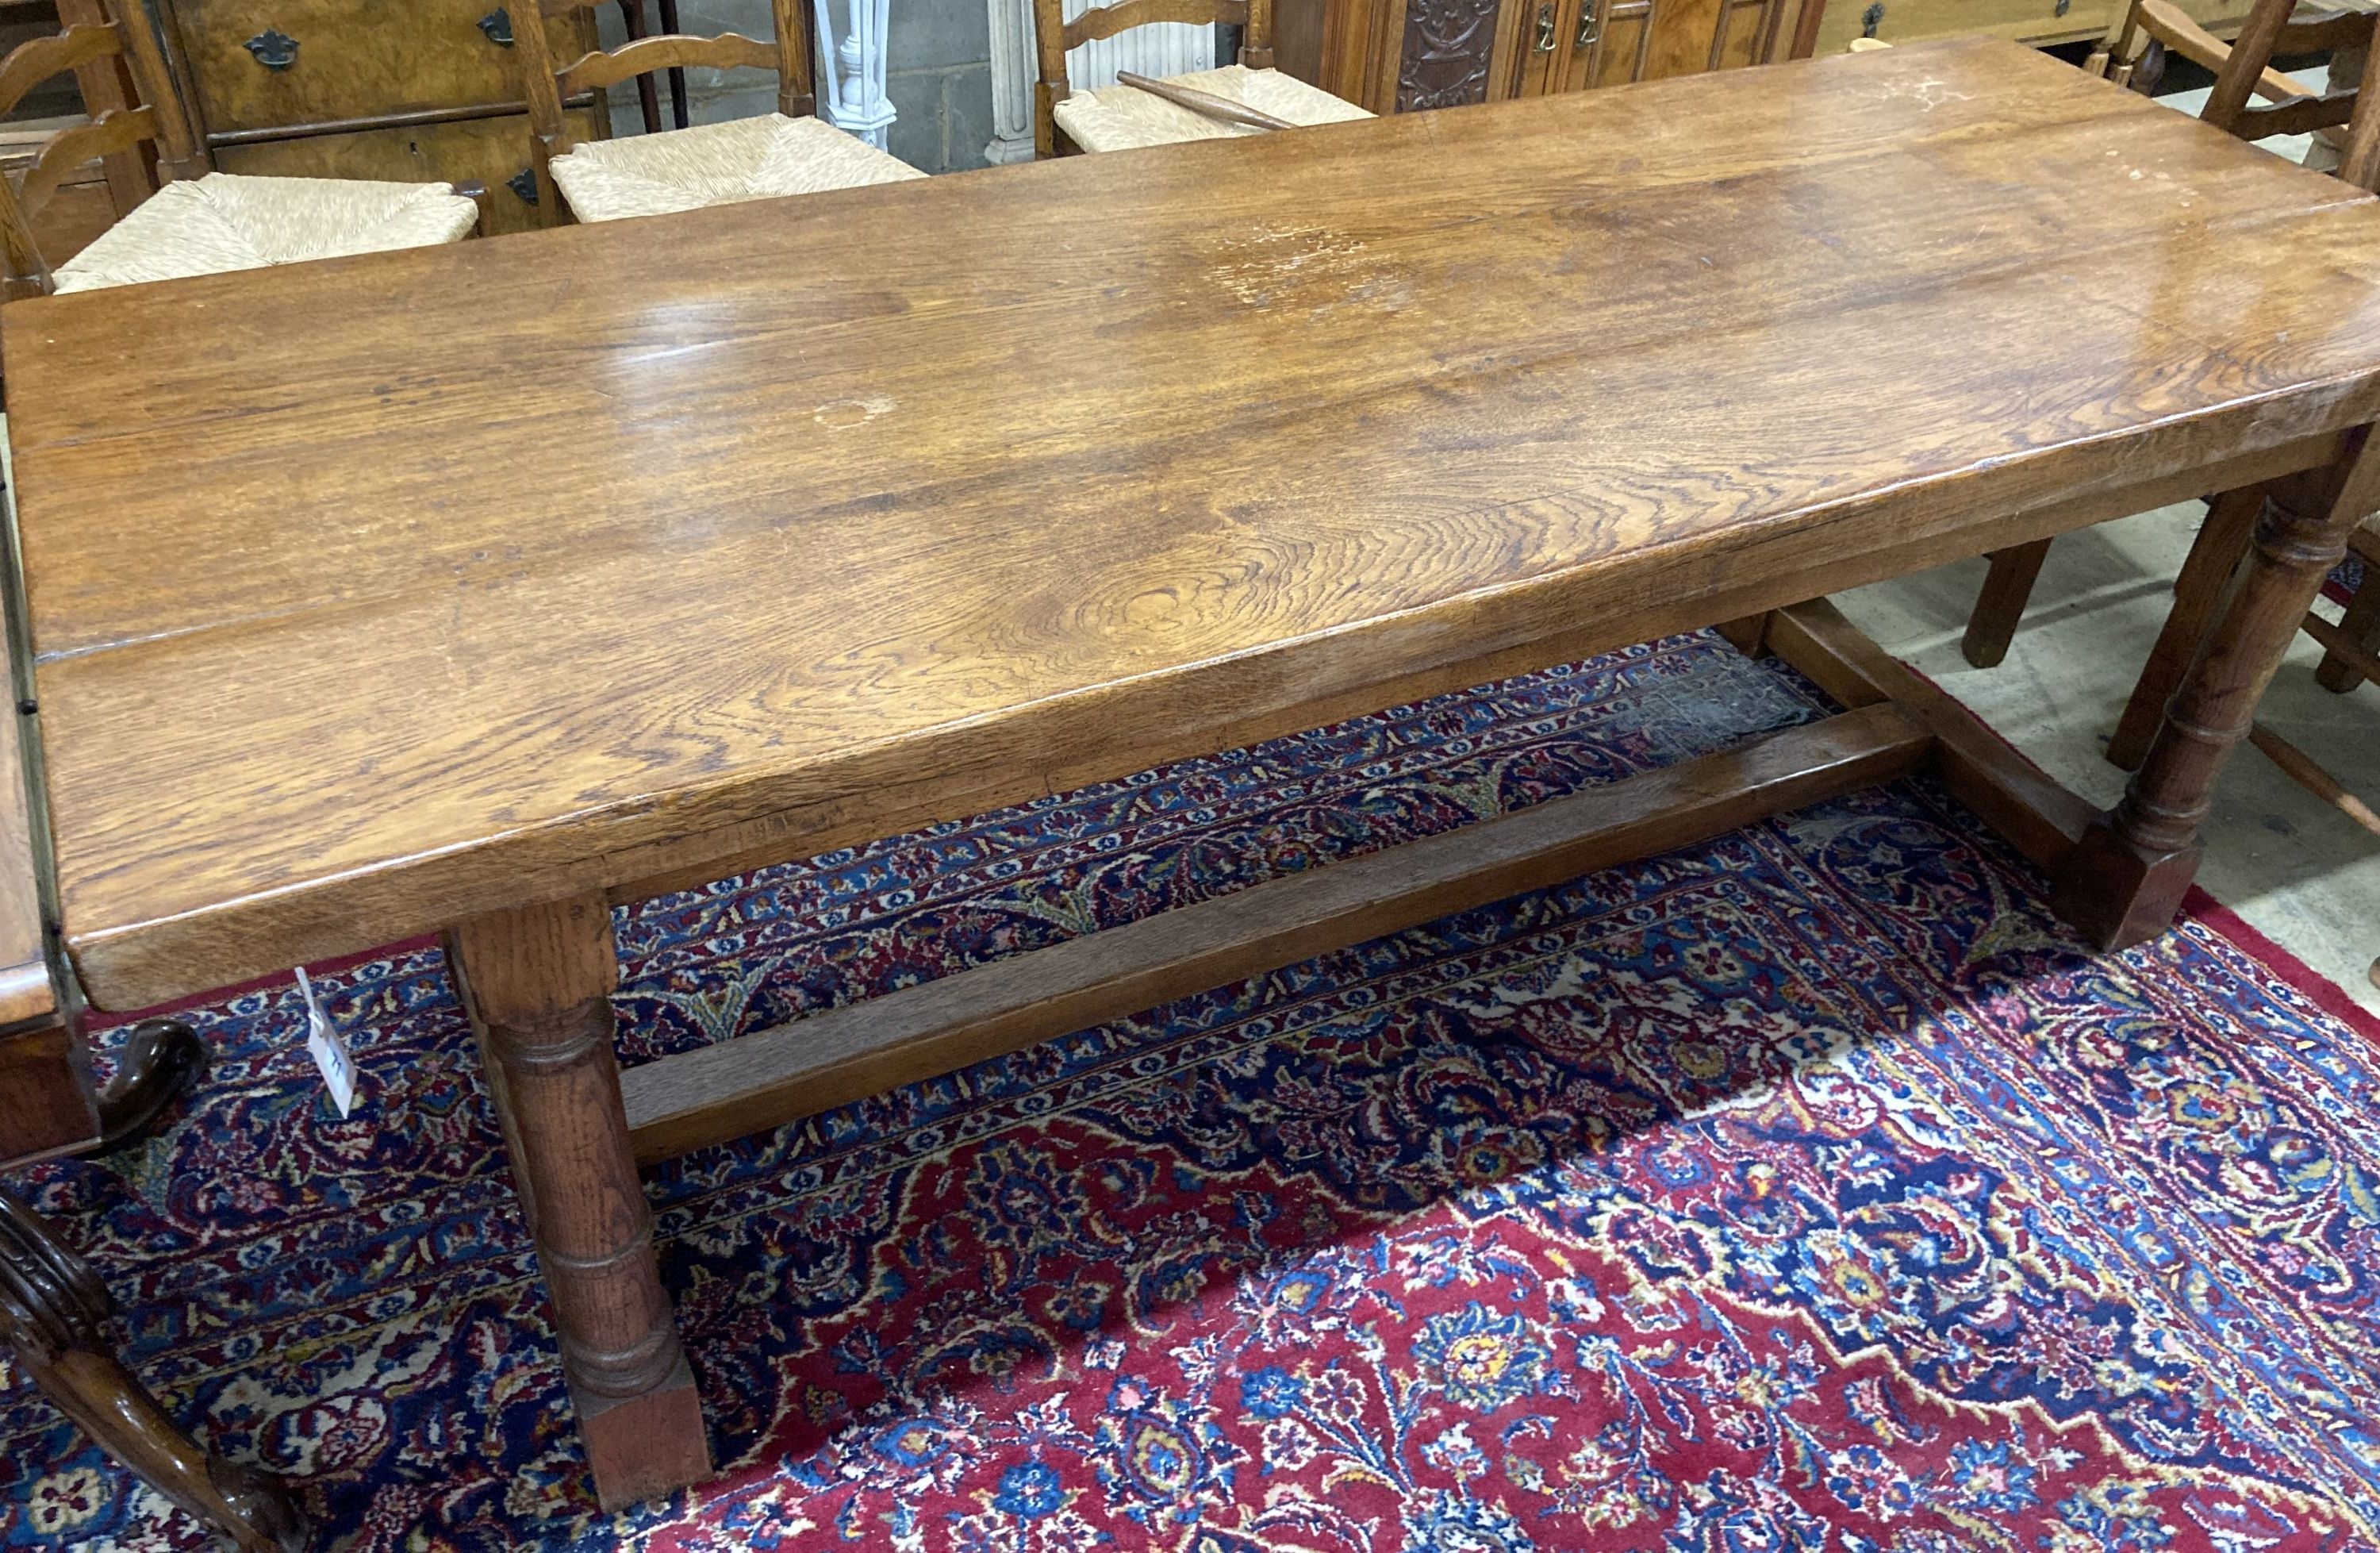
[2054,438,2380,951]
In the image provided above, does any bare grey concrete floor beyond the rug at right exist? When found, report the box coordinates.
[1837,502,2380,1013]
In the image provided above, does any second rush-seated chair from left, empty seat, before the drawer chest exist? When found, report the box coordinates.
[514,0,926,221]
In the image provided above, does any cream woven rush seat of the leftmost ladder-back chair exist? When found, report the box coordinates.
[55,171,478,290]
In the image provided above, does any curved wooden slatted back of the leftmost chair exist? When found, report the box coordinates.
[0,10,207,300]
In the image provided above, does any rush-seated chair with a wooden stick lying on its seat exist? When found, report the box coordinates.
[1033,0,1371,157]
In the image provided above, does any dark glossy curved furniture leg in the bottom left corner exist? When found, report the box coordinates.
[0,1194,307,1553]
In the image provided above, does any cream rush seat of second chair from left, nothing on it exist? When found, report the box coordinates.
[552,114,926,221]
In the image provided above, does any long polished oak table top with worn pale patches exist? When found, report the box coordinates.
[0,40,2380,1008]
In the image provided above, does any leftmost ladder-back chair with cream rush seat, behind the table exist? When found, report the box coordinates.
[0,10,481,300]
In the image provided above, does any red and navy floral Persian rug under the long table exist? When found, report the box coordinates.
[0,636,2380,1553]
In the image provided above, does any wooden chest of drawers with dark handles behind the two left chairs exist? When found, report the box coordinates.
[150,0,607,231]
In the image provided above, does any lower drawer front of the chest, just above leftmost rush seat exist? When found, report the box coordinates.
[214,110,600,236]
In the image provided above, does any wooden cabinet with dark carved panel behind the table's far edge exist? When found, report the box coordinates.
[1273,0,1825,114]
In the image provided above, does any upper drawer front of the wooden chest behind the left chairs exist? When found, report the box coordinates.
[171,0,590,133]
